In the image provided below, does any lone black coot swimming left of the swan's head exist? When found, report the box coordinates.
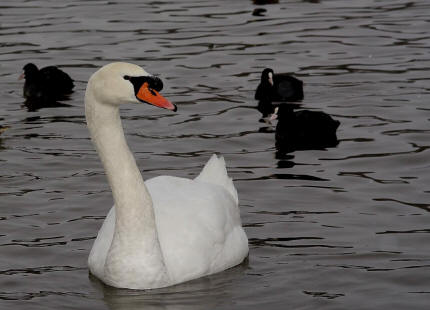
[22,63,74,103]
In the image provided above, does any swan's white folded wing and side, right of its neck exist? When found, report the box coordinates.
[146,176,248,282]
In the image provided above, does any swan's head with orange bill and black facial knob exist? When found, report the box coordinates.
[85,62,176,111]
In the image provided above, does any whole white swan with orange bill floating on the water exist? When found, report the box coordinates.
[85,63,248,289]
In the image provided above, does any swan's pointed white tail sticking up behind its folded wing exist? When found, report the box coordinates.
[195,154,239,204]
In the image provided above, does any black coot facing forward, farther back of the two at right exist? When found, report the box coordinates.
[254,68,303,117]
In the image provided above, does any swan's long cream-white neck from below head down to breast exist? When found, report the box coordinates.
[85,93,166,286]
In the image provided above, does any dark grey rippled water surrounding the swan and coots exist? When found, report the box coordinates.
[0,0,430,309]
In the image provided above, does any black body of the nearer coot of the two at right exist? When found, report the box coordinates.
[275,105,340,153]
